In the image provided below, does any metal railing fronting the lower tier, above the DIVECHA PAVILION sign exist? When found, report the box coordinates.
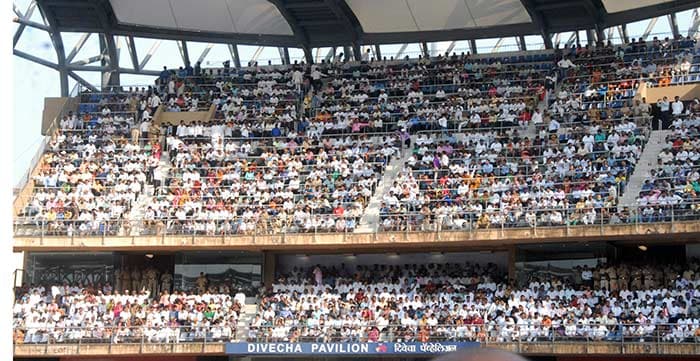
[13,319,700,347]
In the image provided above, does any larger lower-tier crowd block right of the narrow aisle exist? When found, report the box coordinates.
[248,262,700,342]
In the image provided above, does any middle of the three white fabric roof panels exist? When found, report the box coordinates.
[347,0,532,33]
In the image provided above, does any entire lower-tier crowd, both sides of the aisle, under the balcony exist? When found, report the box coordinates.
[13,260,700,343]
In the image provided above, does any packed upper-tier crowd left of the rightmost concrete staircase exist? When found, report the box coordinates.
[12,35,695,236]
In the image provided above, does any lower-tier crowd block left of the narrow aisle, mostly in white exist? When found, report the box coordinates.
[12,283,245,343]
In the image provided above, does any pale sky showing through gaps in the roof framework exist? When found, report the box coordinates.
[12,0,692,184]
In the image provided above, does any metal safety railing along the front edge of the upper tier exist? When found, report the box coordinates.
[14,199,700,238]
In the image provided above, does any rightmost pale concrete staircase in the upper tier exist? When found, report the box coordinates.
[619,130,671,206]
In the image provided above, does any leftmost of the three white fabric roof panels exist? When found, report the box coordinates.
[110,0,293,35]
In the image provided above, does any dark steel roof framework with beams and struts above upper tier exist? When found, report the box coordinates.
[13,0,700,96]
